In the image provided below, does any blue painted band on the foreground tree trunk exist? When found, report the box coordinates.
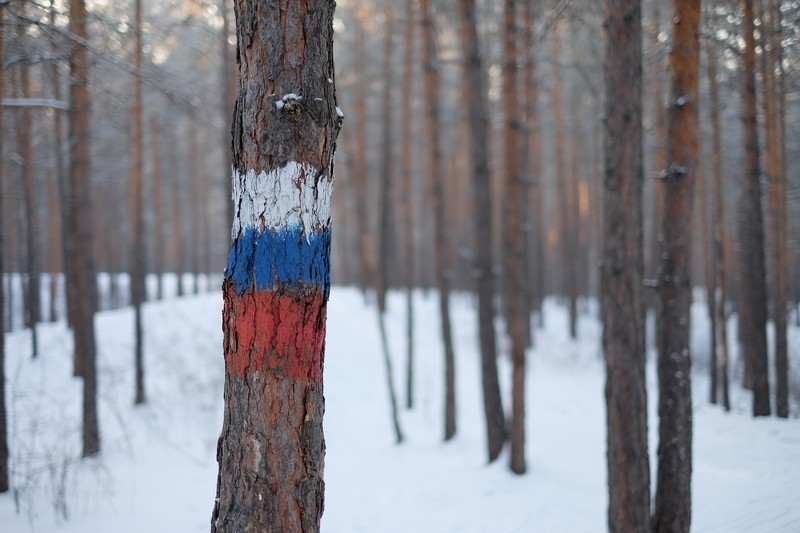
[225,226,331,294]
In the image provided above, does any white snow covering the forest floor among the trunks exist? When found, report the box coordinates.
[0,280,800,533]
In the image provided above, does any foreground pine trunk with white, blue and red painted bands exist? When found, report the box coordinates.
[211,0,340,533]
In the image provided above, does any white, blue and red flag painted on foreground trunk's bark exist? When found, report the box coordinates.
[223,161,333,380]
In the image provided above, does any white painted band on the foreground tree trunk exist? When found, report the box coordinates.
[231,161,333,239]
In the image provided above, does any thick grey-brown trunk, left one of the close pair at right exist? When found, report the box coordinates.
[601,0,650,532]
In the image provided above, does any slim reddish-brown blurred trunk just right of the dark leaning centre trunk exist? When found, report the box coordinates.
[503,0,528,474]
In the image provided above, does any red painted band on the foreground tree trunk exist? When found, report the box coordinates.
[223,283,327,380]
